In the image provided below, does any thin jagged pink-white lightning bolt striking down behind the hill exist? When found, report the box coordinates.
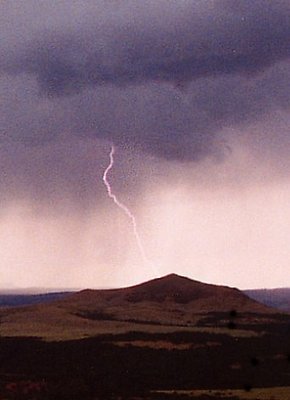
[103,146,156,273]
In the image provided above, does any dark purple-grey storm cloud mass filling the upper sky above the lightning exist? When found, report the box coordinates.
[0,0,290,167]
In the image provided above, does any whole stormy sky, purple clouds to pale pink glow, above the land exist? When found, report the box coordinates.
[0,0,290,288]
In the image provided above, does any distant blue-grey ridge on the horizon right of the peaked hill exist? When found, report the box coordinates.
[244,288,290,312]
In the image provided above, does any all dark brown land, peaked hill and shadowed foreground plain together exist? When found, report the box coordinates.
[0,274,290,400]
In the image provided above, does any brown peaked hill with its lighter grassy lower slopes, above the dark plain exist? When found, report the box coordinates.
[0,274,280,339]
